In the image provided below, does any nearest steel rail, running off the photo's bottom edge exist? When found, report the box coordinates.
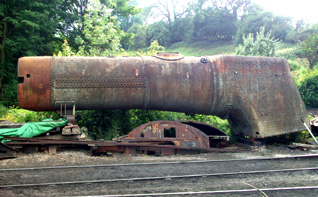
[85,186,318,197]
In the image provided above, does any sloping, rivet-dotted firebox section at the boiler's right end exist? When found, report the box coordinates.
[218,56,309,138]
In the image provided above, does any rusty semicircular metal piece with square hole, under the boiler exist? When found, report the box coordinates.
[122,120,229,148]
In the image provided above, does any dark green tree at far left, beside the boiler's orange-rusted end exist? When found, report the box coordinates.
[0,0,62,105]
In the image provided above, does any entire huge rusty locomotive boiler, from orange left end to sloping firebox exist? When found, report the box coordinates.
[19,55,309,138]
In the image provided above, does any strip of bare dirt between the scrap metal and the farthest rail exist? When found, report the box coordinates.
[0,146,318,168]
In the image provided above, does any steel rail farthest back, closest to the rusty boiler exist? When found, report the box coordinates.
[0,154,318,172]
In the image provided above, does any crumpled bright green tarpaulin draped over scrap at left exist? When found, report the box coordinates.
[0,119,68,143]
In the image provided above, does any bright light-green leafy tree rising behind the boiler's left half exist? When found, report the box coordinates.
[57,0,141,52]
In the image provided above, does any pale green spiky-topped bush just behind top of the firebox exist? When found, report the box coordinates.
[236,27,277,57]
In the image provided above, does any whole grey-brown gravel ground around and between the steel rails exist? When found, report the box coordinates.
[0,146,318,196]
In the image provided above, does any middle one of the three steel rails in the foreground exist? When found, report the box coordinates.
[0,167,318,188]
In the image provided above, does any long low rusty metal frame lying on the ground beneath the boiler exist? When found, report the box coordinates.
[2,137,238,155]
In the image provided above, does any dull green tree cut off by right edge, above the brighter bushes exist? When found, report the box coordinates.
[300,33,318,69]
